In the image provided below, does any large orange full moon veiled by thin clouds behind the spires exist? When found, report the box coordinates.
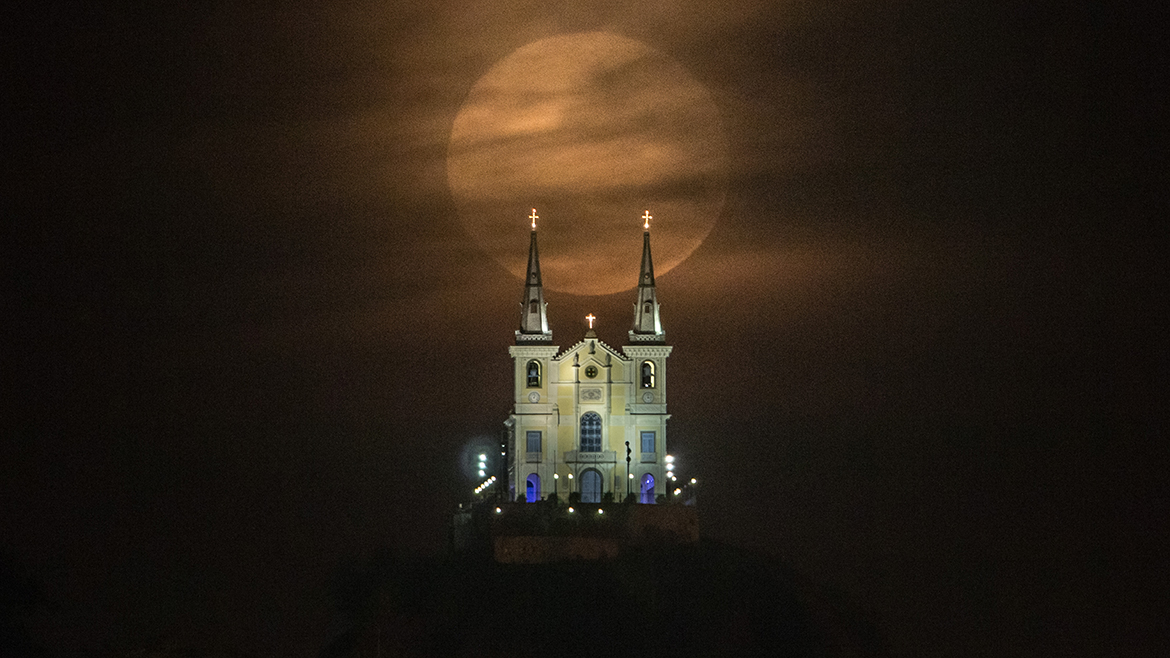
[447,33,728,295]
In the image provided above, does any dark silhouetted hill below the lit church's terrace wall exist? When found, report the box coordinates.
[321,542,887,658]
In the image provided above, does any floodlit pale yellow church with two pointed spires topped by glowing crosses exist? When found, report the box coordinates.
[504,210,670,503]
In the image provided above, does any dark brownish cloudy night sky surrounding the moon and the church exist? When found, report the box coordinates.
[0,0,1170,656]
